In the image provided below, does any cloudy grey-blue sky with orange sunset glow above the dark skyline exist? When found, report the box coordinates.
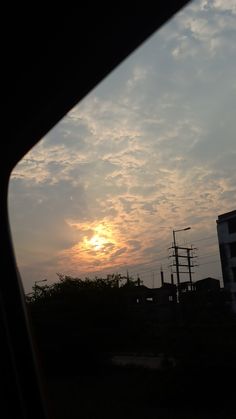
[9,0,236,292]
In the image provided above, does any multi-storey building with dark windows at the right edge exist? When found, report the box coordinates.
[216,210,236,313]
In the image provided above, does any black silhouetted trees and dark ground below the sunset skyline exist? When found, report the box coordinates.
[28,275,236,419]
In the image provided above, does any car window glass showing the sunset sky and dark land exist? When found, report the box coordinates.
[9,0,236,418]
